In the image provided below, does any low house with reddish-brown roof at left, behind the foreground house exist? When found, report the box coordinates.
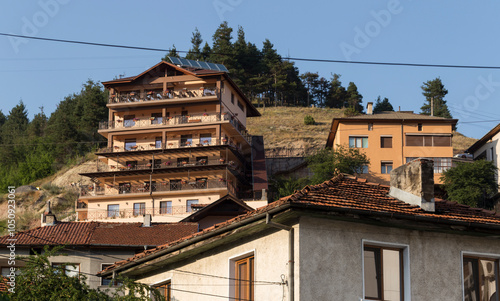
[0,212,198,289]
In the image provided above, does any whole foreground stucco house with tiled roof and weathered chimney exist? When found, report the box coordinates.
[100,160,500,301]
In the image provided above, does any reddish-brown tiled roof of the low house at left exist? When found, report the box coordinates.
[0,222,198,246]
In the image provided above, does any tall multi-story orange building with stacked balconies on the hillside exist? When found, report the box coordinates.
[77,58,267,221]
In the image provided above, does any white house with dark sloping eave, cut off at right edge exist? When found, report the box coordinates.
[466,124,500,185]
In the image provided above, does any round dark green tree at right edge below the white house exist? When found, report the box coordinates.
[441,160,498,208]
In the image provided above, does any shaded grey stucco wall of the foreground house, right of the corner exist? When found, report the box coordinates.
[298,217,500,300]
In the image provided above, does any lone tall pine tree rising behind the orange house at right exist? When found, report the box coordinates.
[420,77,452,118]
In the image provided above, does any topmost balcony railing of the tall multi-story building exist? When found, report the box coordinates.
[109,88,219,104]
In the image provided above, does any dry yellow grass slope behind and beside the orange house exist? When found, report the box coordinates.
[247,107,477,153]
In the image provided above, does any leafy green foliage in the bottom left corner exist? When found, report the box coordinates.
[3,246,165,301]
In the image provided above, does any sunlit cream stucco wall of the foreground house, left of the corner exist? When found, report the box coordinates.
[140,227,292,301]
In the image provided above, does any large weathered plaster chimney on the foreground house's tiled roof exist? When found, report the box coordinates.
[389,158,435,212]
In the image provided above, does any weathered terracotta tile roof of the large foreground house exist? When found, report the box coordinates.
[103,174,500,273]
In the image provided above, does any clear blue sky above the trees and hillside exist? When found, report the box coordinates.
[0,0,500,138]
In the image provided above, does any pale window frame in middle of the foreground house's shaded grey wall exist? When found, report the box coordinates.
[361,239,411,301]
